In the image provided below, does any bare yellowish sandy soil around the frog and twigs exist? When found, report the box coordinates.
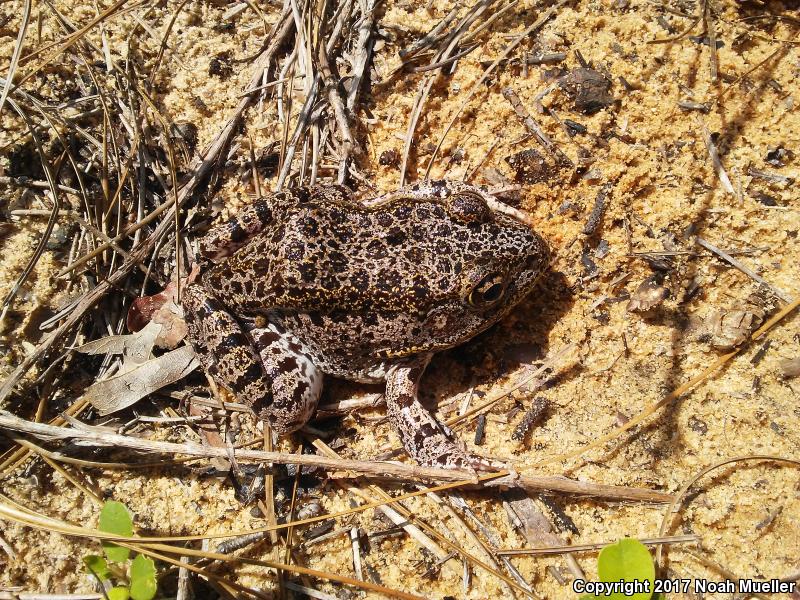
[0,0,800,598]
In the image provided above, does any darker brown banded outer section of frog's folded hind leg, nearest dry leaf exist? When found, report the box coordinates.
[182,285,272,406]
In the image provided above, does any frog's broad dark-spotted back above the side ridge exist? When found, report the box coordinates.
[207,196,503,314]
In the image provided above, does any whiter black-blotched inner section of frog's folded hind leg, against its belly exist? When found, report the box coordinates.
[250,323,323,434]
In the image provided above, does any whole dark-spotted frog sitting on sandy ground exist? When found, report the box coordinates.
[181,180,550,472]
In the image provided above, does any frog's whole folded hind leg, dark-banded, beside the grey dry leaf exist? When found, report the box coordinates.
[182,284,322,434]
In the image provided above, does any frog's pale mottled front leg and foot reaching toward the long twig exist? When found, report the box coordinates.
[386,359,497,471]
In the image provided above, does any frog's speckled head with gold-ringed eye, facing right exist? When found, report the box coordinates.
[392,181,550,350]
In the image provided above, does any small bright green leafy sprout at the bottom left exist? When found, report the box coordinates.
[83,500,157,600]
